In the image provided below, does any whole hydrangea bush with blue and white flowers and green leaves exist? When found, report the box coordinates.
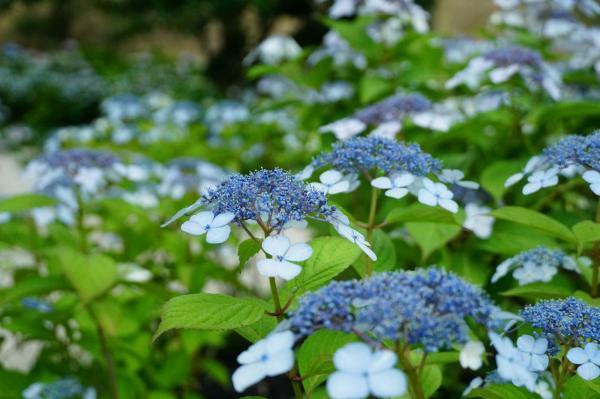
[0,0,600,399]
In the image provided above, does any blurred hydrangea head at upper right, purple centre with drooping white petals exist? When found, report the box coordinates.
[446,47,561,100]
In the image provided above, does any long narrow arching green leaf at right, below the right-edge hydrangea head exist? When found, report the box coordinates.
[491,206,576,243]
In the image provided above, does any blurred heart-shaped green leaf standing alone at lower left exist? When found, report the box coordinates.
[57,247,117,303]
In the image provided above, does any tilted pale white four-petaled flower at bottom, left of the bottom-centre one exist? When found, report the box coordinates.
[231,331,294,392]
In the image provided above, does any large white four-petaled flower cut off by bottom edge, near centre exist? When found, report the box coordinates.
[327,342,406,399]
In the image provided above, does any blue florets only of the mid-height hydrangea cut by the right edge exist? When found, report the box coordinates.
[543,130,600,171]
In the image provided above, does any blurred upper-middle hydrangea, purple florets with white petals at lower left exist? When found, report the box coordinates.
[319,94,431,140]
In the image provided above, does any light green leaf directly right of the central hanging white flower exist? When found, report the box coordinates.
[282,237,362,295]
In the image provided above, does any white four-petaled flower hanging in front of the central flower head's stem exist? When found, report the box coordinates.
[257,235,312,280]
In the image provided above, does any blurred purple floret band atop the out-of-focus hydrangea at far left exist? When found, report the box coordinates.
[36,149,120,174]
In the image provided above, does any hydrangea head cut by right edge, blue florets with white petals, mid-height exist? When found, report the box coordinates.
[505,131,600,196]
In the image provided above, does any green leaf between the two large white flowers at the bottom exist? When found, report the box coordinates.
[297,330,355,392]
